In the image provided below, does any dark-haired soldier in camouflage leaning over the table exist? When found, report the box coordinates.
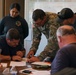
[27,9,60,62]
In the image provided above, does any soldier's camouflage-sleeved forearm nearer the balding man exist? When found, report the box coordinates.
[38,43,59,61]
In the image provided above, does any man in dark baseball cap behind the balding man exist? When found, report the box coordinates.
[56,8,76,29]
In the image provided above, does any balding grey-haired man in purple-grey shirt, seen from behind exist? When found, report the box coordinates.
[51,25,76,74]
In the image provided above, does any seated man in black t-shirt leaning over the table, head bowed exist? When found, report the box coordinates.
[0,28,25,61]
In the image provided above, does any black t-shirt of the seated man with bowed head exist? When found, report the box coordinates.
[0,36,25,56]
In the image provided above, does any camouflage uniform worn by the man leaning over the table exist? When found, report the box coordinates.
[30,12,60,61]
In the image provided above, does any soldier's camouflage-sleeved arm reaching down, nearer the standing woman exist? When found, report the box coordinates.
[30,25,42,54]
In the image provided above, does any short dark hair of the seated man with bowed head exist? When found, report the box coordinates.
[6,28,20,40]
